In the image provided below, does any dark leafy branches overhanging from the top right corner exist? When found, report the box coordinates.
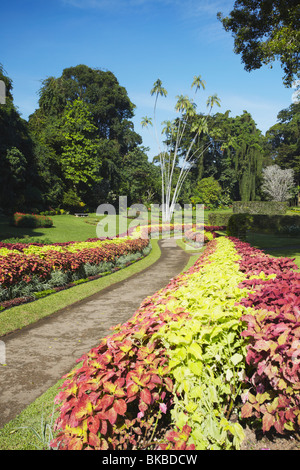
[218,0,300,86]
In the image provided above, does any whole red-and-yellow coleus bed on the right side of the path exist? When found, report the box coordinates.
[52,237,299,450]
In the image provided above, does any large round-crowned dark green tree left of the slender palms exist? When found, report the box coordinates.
[29,64,142,205]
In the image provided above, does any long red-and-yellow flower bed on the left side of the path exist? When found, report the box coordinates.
[0,238,150,310]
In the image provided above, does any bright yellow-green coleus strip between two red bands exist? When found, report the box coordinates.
[154,237,258,450]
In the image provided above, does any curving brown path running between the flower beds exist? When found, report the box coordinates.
[0,239,190,428]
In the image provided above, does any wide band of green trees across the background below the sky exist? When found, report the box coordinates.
[0,61,299,214]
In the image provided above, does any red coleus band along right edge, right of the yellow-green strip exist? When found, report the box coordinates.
[234,239,300,433]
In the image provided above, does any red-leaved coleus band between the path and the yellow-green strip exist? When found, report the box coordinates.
[52,303,190,450]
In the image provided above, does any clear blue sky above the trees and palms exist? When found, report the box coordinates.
[0,0,293,157]
